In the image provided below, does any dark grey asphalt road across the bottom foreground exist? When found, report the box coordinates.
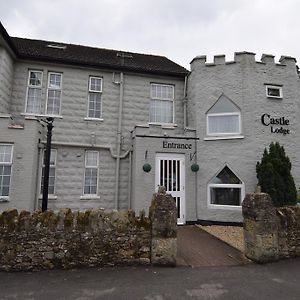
[0,258,300,300]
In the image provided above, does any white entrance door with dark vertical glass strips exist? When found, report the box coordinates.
[155,153,185,224]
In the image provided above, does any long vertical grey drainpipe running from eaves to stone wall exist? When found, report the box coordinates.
[113,72,124,209]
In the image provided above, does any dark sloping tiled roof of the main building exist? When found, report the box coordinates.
[0,22,189,77]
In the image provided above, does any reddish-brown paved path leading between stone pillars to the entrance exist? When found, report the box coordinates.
[177,225,246,267]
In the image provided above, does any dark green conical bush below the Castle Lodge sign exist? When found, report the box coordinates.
[256,142,297,206]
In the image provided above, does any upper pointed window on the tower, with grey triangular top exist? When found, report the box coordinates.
[206,95,241,136]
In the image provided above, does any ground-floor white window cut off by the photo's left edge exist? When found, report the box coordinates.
[0,144,13,199]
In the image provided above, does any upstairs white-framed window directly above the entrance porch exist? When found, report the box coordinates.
[150,83,174,123]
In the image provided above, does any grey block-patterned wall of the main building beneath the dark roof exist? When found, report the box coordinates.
[10,62,184,209]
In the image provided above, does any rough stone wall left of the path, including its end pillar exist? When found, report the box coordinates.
[0,193,177,271]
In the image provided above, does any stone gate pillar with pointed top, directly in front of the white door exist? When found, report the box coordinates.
[149,187,177,266]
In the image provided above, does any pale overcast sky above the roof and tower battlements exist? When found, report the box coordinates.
[0,0,300,69]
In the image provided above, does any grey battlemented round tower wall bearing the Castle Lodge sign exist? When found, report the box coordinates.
[188,52,300,222]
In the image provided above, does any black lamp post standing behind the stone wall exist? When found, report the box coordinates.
[42,117,53,211]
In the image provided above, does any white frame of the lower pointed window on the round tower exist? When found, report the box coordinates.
[207,165,245,210]
